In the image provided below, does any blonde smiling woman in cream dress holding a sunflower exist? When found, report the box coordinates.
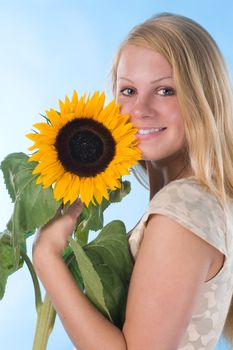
[33,14,233,350]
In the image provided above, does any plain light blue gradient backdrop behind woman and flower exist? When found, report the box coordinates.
[0,0,233,350]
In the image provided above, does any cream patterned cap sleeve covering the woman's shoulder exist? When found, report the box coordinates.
[147,177,227,254]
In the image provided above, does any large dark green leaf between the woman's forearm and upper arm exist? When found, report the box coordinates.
[72,220,133,328]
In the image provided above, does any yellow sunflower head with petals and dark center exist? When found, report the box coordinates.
[26,91,141,206]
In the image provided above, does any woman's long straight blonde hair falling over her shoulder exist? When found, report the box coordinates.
[112,13,233,345]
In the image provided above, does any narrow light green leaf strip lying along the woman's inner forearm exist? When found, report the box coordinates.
[69,238,111,319]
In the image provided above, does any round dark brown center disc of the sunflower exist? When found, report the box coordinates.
[55,118,116,177]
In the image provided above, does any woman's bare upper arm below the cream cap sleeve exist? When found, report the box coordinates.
[123,214,219,350]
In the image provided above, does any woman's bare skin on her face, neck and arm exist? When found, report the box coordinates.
[33,46,223,350]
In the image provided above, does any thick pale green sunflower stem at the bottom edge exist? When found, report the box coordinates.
[32,294,56,350]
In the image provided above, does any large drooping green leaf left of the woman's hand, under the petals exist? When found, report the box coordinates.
[1,153,61,240]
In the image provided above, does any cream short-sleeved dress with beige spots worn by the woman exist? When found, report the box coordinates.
[129,177,233,350]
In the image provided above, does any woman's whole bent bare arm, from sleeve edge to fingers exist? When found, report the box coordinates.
[33,202,215,350]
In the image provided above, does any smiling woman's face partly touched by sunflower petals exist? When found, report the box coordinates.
[116,45,185,161]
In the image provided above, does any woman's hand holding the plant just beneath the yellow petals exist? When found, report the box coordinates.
[33,200,83,264]
